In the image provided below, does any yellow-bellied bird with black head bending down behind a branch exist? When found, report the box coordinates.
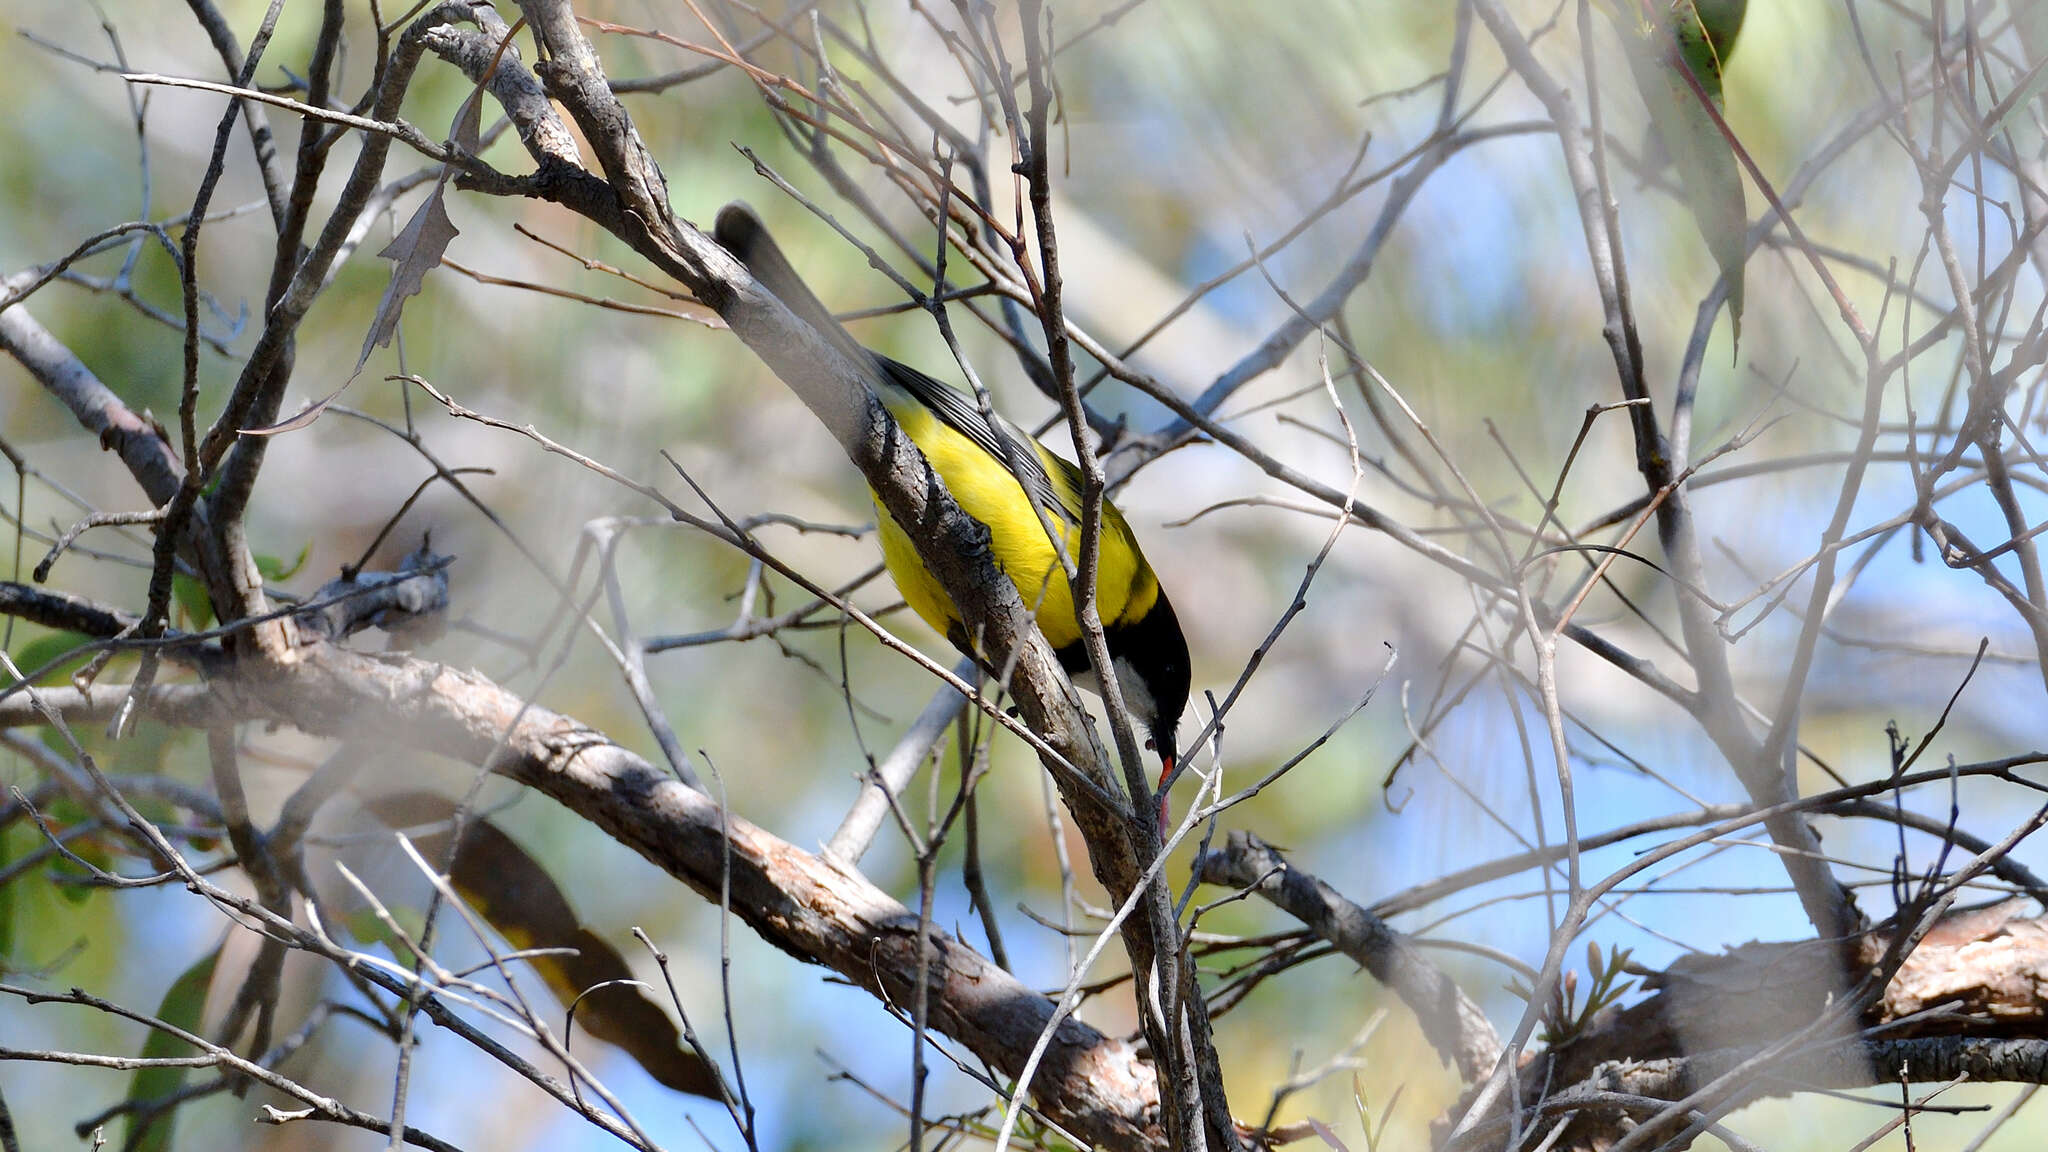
[713,203,1192,826]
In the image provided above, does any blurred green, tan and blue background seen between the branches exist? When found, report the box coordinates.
[0,0,2048,1150]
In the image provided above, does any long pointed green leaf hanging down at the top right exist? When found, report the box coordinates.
[1620,0,1749,344]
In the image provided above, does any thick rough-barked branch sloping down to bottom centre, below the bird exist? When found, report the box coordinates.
[229,644,1161,1148]
